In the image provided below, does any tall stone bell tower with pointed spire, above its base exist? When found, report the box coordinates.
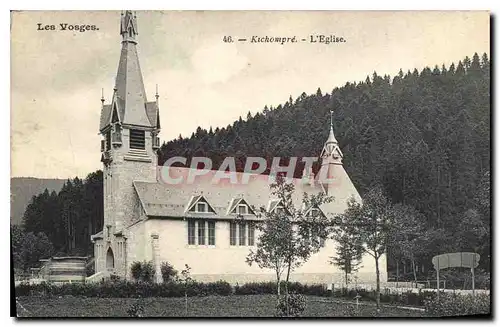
[99,10,160,238]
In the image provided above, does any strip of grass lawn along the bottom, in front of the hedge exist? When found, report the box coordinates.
[17,295,425,317]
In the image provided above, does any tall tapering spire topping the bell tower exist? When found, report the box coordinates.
[113,10,157,128]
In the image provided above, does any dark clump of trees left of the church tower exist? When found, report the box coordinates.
[12,170,104,268]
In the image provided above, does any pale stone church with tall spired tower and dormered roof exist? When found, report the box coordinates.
[92,11,387,284]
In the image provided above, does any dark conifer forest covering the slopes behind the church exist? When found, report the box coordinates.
[13,54,491,280]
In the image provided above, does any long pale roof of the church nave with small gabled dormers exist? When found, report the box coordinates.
[134,165,361,219]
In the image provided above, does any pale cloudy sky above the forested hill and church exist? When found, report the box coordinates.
[11,11,490,178]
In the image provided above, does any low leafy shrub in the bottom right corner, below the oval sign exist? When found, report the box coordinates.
[425,292,491,317]
